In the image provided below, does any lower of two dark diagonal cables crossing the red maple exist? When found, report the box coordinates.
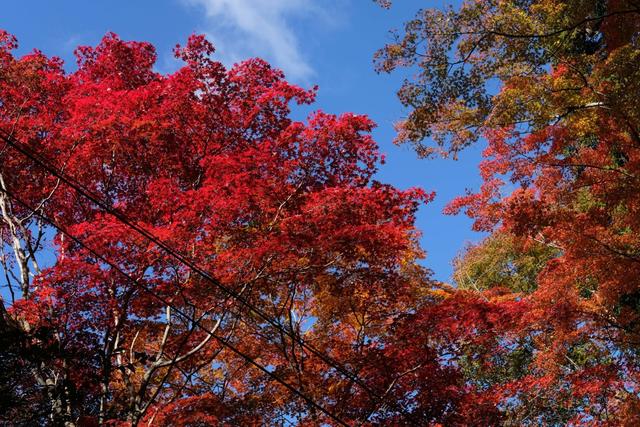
[0,181,349,427]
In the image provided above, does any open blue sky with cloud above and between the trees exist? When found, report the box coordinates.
[0,0,481,280]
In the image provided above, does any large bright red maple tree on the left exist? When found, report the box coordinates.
[0,33,450,425]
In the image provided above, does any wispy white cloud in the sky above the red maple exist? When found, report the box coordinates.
[184,0,328,82]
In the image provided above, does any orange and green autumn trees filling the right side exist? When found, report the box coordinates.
[377,0,640,425]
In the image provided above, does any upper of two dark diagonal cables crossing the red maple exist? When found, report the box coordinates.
[0,129,396,412]
